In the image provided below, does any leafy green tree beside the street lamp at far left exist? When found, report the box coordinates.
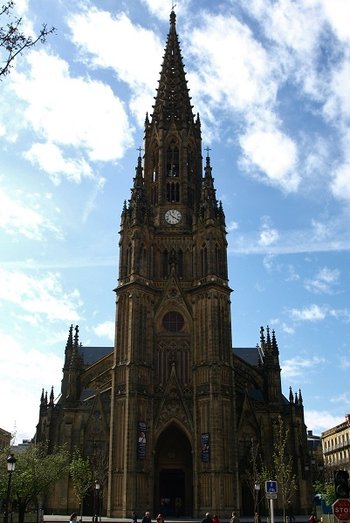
[0,444,69,523]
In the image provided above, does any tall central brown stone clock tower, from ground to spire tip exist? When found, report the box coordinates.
[108,12,237,517]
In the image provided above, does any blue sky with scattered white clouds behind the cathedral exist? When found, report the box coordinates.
[0,0,350,441]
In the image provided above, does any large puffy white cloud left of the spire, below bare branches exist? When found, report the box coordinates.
[11,50,132,172]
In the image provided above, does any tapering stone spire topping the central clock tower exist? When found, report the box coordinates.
[152,11,194,127]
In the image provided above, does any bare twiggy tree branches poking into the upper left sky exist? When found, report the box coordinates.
[0,0,55,79]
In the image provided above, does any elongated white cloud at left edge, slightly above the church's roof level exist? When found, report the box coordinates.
[0,268,82,322]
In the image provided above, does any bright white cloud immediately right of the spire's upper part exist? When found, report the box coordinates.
[186,14,277,114]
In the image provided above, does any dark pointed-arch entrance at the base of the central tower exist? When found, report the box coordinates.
[154,424,193,517]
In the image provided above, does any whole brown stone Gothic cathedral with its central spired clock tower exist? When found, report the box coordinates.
[36,11,311,519]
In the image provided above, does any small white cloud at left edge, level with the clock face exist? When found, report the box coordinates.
[0,188,62,241]
